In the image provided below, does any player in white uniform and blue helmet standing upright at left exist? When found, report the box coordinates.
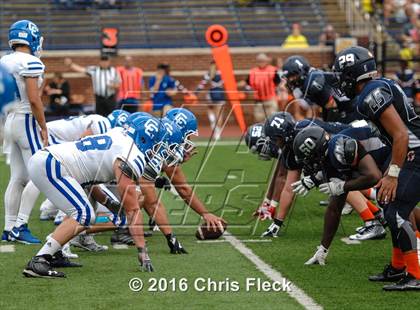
[0,20,48,243]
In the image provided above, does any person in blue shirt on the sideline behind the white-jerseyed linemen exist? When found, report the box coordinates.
[149,63,178,116]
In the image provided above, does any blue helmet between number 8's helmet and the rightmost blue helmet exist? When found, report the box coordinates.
[161,118,184,167]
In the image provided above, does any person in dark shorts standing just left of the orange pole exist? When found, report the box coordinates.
[196,61,226,140]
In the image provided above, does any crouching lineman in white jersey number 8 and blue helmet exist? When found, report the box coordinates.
[23,117,167,278]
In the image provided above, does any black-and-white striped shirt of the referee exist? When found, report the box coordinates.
[86,66,120,97]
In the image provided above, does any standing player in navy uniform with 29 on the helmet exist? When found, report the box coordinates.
[334,46,420,291]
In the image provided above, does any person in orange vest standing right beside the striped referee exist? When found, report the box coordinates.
[117,56,144,113]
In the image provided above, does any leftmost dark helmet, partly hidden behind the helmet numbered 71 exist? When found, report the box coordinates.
[245,123,279,160]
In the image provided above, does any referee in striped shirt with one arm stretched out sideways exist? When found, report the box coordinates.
[64,55,120,116]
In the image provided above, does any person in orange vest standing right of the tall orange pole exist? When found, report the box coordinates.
[238,53,280,122]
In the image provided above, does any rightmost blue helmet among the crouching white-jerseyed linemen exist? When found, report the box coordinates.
[165,108,198,152]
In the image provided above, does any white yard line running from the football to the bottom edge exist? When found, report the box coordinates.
[224,232,323,310]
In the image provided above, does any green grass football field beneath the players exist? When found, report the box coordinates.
[0,142,420,309]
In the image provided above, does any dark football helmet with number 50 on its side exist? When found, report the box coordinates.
[293,126,330,171]
